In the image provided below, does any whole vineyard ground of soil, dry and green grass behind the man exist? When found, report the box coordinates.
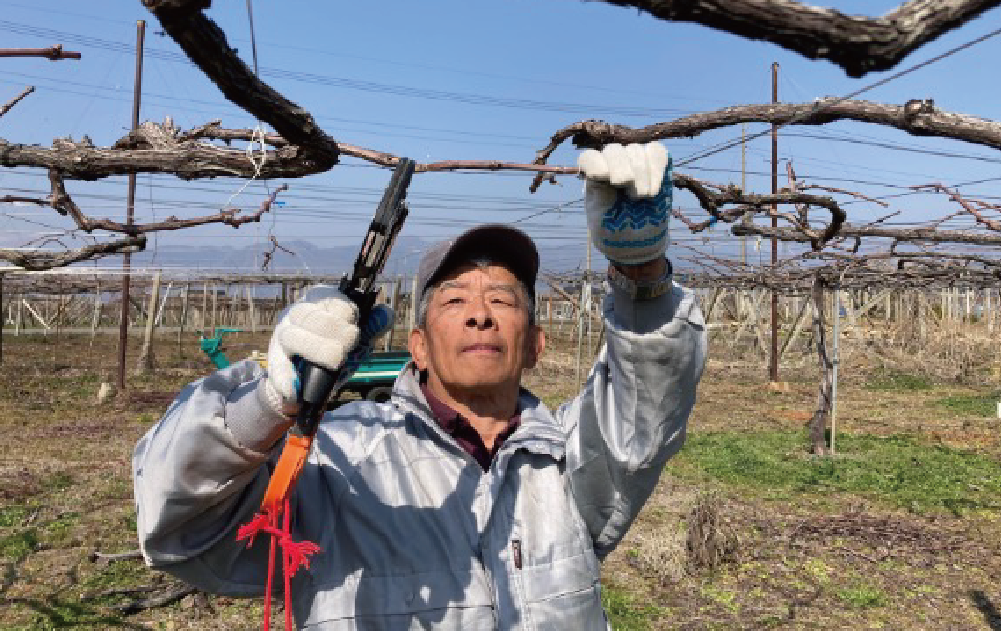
[0,332,1001,629]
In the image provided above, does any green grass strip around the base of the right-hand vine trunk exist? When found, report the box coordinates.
[672,431,1001,515]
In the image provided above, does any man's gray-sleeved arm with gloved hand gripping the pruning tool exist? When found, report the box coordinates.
[133,285,380,595]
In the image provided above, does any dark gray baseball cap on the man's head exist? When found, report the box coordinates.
[417,223,539,306]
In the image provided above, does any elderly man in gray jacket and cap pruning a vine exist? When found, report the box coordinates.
[134,143,706,631]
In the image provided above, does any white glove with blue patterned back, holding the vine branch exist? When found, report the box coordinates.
[577,142,672,265]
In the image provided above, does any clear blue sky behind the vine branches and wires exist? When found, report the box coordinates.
[0,0,1001,270]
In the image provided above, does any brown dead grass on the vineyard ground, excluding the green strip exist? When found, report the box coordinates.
[0,334,1001,630]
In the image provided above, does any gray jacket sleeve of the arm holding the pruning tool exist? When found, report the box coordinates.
[132,362,288,596]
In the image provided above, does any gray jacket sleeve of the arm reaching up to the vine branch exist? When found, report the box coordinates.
[557,284,707,558]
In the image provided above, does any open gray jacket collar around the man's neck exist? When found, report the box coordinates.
[392,361,567,460]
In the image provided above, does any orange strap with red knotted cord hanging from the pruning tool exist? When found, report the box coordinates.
[236,434,319,631]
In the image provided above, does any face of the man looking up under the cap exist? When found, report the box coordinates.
[409,264,546,396]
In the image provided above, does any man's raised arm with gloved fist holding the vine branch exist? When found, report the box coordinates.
[558,142,707,557]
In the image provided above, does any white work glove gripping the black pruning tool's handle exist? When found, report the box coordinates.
[265,284,393,415]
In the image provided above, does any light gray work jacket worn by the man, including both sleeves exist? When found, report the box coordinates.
[133,285,706,631]
